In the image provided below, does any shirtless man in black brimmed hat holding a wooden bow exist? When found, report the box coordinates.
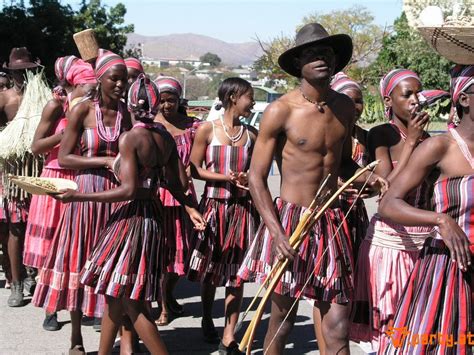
[239,23,385,354]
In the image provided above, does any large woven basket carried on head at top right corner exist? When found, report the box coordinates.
[418,26,474,65]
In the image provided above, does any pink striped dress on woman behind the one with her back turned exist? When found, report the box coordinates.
[159,117,201,276]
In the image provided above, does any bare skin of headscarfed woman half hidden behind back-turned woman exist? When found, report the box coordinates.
[155,91,195,325]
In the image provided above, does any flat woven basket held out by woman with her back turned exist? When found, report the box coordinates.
[8,174,77,195]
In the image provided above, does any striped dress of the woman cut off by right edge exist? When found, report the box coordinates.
[382,129,474,355]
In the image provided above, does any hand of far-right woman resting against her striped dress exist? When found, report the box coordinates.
[437,214,471,271]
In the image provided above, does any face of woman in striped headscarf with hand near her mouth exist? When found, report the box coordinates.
[384,78,421,122]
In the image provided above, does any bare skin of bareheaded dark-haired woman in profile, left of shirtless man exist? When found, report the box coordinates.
[190,88,257,346]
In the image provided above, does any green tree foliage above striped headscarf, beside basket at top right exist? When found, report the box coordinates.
[370,13,453,90]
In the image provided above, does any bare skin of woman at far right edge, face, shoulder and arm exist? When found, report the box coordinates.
[379,85,474,272]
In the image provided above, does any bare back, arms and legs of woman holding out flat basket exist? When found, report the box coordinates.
[55,119,206,354]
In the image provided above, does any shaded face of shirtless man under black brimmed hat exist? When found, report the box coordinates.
[299,46,336,80]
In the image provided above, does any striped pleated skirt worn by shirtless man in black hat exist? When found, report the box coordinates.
[239,198,353,304]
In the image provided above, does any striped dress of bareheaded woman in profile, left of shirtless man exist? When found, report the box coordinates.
[188,123,260,287]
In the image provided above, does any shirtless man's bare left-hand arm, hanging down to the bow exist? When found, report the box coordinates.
[249,101,296,261]
